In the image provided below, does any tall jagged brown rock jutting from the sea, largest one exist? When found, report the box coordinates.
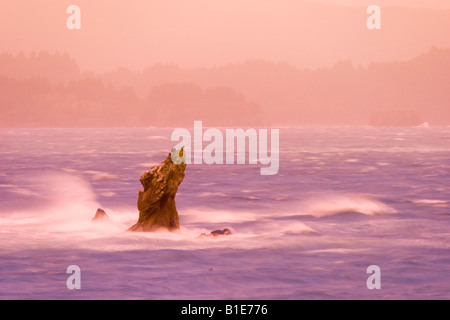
[128,148,186,231]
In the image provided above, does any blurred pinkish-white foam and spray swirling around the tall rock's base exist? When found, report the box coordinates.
[0,173,395,255]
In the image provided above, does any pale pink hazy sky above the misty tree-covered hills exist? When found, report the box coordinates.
[0,0,450,72]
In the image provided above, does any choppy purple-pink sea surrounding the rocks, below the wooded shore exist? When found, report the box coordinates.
[0,127,450,299]
